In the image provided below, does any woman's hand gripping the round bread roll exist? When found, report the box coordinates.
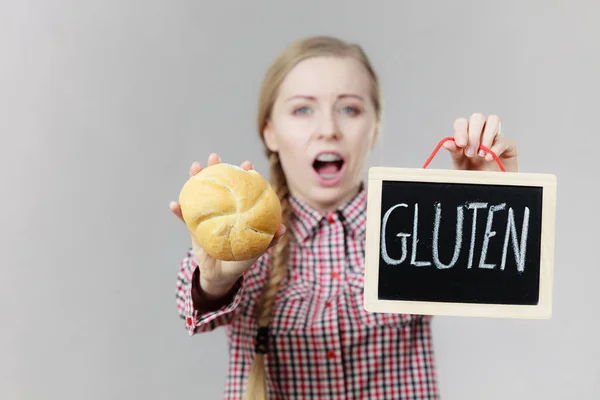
[170,153,285,299]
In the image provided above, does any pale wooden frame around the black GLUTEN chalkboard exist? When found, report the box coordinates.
[364,167,556,319]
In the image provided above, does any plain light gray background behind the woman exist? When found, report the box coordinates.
[0,0,600,400]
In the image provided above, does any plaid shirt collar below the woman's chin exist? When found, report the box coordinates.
[290,183,367,244]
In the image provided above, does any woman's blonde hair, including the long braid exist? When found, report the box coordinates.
[244,36,382,400]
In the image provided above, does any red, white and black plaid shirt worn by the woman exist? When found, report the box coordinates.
[177,189,438,400]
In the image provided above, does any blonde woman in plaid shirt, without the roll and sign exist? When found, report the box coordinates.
[171,37,517,400]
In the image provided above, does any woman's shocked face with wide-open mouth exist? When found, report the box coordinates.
[264,57,378,210]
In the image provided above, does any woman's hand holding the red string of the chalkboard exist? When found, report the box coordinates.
[443,114,519,172]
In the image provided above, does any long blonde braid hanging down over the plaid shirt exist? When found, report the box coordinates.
[244,153,291,400]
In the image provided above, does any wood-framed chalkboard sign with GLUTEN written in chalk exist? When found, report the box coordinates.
[364,167,556,318]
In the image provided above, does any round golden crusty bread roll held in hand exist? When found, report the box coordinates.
[179,163,281,261]
